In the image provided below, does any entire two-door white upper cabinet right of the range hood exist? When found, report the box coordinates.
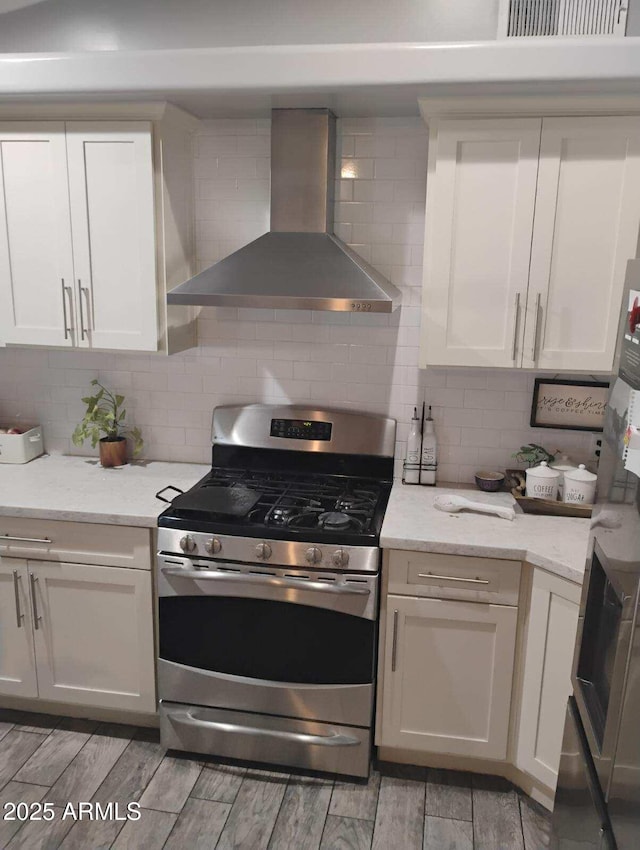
[420,111,640,372]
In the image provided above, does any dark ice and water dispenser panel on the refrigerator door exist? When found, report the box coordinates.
[572,542,632,795]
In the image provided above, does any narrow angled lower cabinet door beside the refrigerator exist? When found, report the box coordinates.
[516,569,580,790]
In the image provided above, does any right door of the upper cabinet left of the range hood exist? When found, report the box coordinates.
[66,121,158,351]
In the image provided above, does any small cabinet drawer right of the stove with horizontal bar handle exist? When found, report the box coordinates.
[388,550,521,605]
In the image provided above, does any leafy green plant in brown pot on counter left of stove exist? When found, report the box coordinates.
[71,378,144,467]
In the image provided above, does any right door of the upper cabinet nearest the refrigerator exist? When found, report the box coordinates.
[522,117,640,372]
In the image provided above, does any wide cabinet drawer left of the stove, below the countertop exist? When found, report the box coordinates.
[0,510,151,570]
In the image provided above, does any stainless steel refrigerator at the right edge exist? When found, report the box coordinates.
[553,260,640,850]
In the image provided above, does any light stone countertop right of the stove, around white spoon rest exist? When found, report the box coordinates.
[380,483,591,584]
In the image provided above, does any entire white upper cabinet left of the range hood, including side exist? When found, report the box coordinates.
[0,107,195,351]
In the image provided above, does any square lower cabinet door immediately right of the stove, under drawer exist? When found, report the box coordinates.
[378,594,518,759]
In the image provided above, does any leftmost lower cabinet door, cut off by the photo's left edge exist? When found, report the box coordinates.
[0,559,38,697]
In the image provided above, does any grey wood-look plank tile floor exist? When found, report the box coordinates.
[0,710,552,850]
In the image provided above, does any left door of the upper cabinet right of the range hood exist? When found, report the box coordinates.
[420,118,542,367]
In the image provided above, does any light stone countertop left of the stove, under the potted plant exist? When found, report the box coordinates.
[0,455,211,528]
